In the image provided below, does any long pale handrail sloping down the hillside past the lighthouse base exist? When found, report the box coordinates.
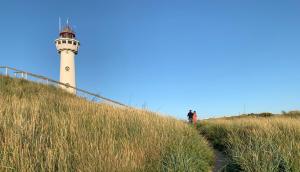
[0,66,129,107]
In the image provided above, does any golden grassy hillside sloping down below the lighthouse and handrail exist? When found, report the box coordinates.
[0,76,213,171]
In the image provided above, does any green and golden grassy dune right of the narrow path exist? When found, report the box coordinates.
[198,114,300,172]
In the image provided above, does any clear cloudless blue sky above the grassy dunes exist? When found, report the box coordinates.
[0,0,300,118]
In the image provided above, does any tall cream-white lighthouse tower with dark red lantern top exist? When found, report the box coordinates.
[55,24,80,94]
